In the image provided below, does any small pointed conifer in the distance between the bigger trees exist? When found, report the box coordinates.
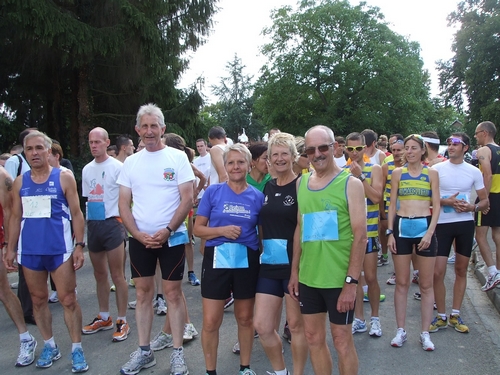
[209,55,263,141]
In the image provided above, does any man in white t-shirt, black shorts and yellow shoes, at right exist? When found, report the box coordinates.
[429,133,488,333]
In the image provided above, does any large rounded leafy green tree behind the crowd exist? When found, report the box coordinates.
[255,0,432,138]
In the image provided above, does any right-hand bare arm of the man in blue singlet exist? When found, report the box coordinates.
[60,170,85,270]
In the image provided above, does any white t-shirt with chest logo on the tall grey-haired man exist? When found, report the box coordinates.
[118,147,194,235]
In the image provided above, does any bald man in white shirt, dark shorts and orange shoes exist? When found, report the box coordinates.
[82,128,130,342]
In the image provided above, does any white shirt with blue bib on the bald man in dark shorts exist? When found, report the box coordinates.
[82,157,123,220]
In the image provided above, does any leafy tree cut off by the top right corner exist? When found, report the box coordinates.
[438,0,500,125]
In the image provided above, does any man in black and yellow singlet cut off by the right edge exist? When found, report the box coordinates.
[474,121,500,292]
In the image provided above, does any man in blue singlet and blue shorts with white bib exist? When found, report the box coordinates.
[6,131,89,372]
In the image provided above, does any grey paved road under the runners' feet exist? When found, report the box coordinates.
[0,241,500,375]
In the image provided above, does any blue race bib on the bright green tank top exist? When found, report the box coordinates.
[302,210,339,242]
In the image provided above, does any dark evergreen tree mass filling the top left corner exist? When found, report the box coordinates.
[0,0,217,156]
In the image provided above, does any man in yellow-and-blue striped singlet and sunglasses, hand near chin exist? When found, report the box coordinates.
[346,133,383,337]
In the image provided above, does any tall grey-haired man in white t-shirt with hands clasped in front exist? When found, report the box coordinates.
[118,104,194,375]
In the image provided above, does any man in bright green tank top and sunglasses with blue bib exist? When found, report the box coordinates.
[288,125,367,375]
